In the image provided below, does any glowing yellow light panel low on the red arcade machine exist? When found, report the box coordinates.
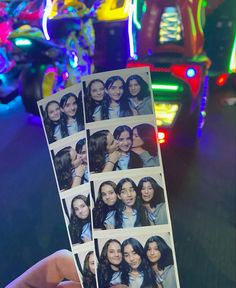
[155,103,180,127]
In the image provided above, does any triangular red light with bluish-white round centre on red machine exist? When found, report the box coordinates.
[171,65,202,97]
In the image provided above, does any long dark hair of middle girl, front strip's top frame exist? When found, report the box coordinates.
[105,76,133,119]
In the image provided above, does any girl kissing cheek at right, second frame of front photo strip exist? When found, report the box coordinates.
[132,123,159,167]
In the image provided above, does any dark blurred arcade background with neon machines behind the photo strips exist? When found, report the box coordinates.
[0,0,236,288]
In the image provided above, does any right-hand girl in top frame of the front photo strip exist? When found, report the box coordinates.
[126,75,153,115]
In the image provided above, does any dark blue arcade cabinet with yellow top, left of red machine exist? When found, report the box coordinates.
[94,0,131,72]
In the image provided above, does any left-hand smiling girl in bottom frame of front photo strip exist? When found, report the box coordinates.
[98,239,122,288]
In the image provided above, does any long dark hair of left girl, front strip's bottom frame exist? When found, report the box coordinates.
[98,239,121,288]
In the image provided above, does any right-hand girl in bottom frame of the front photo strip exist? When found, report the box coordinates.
[145,236,177,288]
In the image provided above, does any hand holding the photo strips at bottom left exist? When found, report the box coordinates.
[5,250,82,288]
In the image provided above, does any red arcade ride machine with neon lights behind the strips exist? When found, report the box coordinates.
[127,0,210,145]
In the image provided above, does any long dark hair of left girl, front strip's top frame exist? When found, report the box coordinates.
[84,79,109,122]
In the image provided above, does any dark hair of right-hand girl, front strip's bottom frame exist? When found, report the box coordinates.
[144,236,174,270]
